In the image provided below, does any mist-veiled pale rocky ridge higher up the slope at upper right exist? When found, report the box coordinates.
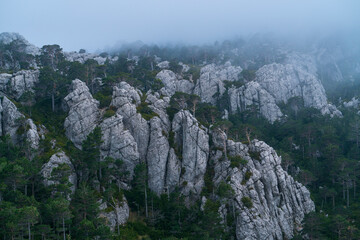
[156,53,342,123]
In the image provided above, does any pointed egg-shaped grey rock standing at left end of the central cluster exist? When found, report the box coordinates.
[64,79,100,149]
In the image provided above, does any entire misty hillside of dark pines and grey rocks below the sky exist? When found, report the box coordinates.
[0,33,360,239]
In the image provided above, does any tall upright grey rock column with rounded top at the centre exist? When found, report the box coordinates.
[172,110,209,195]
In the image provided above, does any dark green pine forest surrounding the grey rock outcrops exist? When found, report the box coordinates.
[0,34,360,239]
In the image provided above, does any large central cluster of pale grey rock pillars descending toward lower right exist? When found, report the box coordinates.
[59,80,314,235]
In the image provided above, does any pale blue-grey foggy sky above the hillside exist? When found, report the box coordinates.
[0,0,360,51]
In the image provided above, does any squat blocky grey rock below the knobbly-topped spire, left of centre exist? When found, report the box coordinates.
[100,114,139,179]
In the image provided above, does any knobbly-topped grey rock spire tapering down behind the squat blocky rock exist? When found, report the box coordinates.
[111,82,149,160]
